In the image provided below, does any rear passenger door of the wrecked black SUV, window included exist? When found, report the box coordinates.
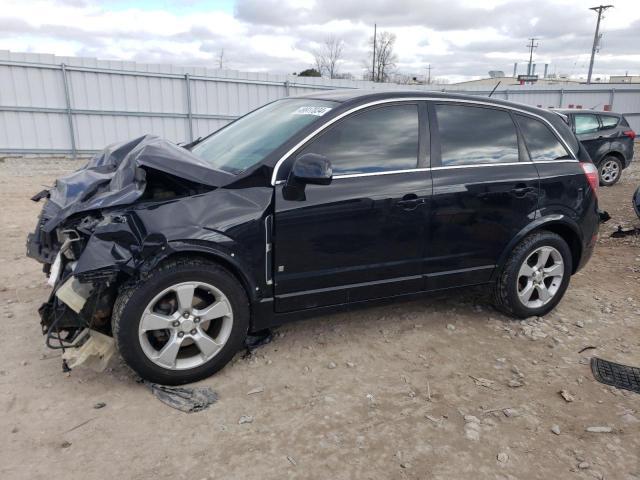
[425,102,538,289]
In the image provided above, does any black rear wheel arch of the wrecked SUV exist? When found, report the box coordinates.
[492,214,582,279]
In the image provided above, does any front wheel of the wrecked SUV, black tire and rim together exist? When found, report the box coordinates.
[112,258,249,385]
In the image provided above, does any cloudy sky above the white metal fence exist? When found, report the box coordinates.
[0,0,640,82]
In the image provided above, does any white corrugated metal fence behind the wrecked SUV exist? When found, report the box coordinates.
[0,51,640,156]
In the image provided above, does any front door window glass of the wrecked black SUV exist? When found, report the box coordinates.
[300,104,419,175]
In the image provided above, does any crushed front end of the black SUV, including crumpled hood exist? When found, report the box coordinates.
[27,136,232,360]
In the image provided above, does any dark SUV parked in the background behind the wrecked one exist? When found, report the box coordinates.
[556,109,636,186]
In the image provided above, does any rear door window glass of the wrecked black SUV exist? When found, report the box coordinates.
[435,105,519,166]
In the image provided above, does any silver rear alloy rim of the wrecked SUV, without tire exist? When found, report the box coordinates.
[516,246,564,308]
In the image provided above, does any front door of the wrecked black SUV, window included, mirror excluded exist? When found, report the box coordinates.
[273,102,432,312]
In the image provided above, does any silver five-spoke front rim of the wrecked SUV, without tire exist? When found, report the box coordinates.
[138,282,233,370]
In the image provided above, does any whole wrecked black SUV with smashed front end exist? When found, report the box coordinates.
[28,90,599,384]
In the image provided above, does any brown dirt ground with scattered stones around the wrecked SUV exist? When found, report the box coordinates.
[0,149,640,480]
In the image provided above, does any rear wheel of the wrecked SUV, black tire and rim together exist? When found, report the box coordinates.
[494,231,573,318]
